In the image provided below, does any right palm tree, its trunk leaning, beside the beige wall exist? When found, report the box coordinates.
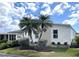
[39,15,52,41]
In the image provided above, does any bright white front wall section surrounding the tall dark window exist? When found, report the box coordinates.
[51,25,70,44]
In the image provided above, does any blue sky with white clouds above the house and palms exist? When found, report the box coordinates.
[0,2,79,32]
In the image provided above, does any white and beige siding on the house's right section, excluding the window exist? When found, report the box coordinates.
[42,25,75,45]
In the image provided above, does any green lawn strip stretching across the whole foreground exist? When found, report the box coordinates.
[0,48,79,57]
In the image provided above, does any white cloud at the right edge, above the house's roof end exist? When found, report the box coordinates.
[63,6,79,25]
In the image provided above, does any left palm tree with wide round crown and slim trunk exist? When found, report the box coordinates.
[19,17,38,43]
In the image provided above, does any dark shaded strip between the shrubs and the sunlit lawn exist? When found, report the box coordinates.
[14,46,69,52]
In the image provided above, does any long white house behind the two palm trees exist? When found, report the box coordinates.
[0,24,76,46]
